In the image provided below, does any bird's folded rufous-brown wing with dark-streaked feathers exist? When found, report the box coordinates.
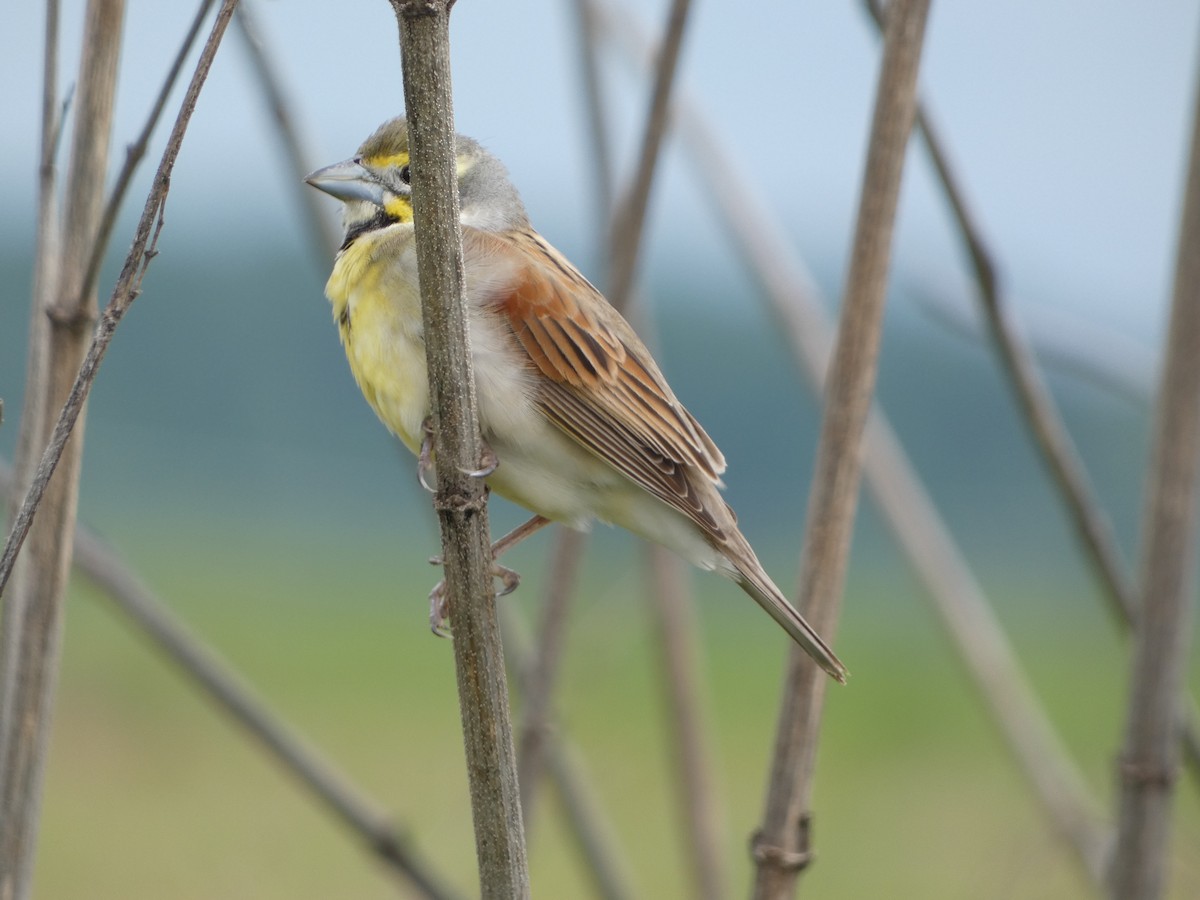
[463,228,725,540]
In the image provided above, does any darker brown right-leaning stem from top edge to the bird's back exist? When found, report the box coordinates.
[606,0,691,310]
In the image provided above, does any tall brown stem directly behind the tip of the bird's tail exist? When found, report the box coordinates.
[754,0,929,900]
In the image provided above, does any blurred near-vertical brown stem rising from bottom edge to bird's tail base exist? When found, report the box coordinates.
[647,547,728,900]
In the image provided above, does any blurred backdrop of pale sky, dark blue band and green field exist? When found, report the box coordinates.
[0,0,1200,898]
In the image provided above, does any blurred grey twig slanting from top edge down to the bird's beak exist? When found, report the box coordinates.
[234,0,342,259]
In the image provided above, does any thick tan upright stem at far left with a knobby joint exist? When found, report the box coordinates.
[0,0,125,900]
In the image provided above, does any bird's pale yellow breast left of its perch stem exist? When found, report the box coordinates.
[325,224,430,452]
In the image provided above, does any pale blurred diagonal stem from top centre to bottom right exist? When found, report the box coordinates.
[595,0,1108,884]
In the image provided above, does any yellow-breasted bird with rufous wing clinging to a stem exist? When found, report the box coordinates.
[305,116,847,683]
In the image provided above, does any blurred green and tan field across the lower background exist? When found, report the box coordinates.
[36,513,1200,900]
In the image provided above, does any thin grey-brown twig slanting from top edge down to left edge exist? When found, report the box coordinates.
[0,0,238,600]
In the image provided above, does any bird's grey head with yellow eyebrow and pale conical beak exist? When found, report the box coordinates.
[305,118,528,244]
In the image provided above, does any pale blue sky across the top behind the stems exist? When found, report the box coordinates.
[0,0,1200,352]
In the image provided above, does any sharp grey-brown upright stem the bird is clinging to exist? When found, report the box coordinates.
[390,0,529,898]
